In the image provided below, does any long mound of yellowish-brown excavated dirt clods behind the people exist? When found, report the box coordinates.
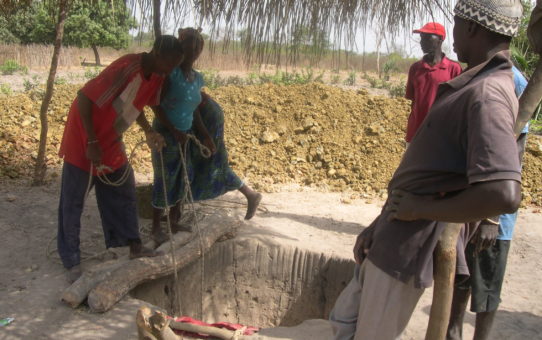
[0,83,542,205]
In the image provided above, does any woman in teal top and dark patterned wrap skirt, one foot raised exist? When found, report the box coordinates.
[151,28,262,243]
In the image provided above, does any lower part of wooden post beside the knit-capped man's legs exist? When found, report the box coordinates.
[425,223,463,340]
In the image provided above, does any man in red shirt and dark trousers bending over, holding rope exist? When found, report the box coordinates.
[57,35,183,281]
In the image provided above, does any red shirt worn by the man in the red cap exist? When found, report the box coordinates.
[405,57,461,143]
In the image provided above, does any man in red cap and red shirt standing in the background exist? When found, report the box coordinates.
[405,22,461,145]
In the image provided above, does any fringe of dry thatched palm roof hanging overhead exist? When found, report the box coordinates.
[0,0,455,61]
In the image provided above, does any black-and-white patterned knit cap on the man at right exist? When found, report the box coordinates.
[454,0,523,37]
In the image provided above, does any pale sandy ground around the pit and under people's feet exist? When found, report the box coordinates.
[0,182,542,340]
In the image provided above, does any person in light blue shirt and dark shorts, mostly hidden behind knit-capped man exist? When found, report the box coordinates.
[446,66,529,340]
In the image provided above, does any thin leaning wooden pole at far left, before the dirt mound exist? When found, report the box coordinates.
[32,0,69,185]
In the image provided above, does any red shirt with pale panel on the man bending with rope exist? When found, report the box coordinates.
[59,54,164,175]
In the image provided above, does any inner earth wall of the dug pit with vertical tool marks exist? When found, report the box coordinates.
[131,239,354,327]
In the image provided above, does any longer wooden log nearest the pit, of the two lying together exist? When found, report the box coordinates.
[88,216,240,313]
